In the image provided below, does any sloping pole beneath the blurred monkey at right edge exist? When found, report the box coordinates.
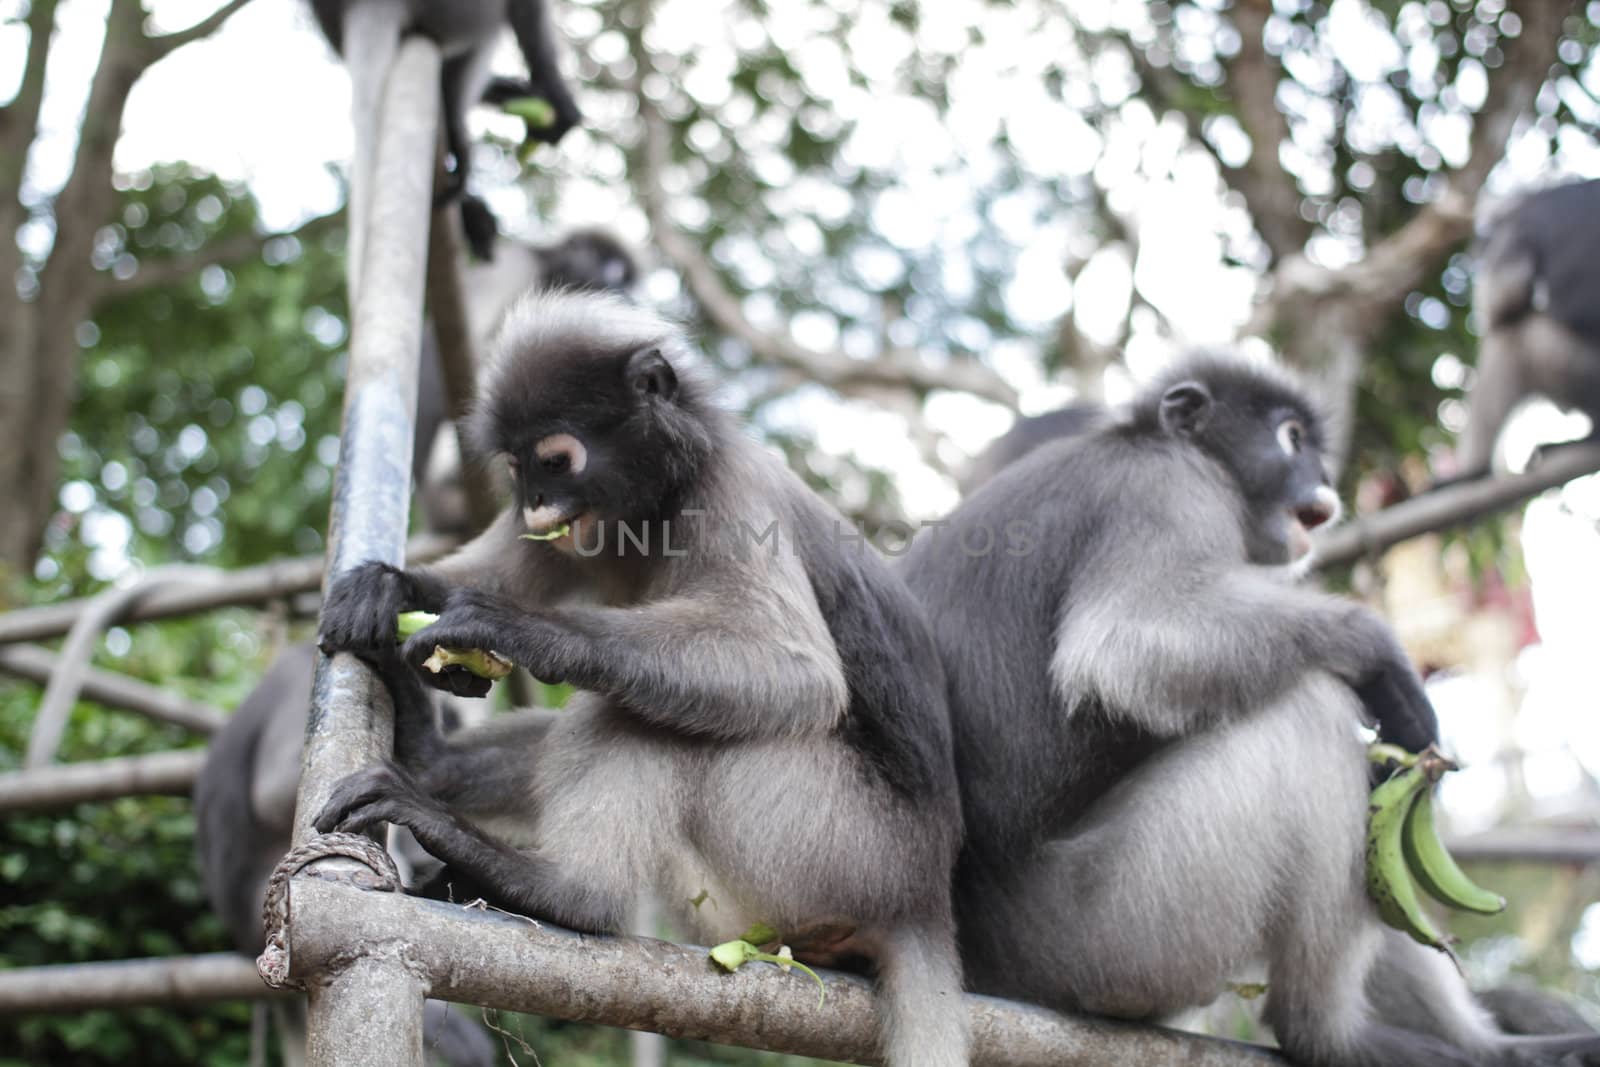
[1317,442,1600,568]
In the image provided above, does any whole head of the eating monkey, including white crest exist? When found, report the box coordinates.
[469,291,725,544]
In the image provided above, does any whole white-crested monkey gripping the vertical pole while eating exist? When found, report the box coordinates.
[315,293,966,1067]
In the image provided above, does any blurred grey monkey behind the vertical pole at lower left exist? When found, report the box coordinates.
[195,645,499,1067]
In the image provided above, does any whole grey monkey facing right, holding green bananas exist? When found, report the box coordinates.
[904,358,1593,1067]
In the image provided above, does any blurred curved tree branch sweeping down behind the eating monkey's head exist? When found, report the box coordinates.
[617,19,1018,408]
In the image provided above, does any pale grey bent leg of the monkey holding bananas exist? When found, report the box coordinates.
[960,675,1482,1067]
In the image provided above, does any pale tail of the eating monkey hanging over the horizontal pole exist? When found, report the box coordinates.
[878,923,968,1067]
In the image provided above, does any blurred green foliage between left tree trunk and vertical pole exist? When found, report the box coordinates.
[42,166,346,595]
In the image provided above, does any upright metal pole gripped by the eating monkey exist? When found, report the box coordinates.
[290,37,440,1067]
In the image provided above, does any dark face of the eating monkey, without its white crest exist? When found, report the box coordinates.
[475,335,713,549]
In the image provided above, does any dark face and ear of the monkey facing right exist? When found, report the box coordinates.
[1160,368,1339,565]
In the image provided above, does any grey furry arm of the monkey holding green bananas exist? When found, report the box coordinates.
[1051,565,1438,752]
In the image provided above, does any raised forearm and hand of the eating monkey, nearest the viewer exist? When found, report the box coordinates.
[403,575,850,739]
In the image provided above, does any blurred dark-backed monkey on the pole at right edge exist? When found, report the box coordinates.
[1442,179,1600,483]
